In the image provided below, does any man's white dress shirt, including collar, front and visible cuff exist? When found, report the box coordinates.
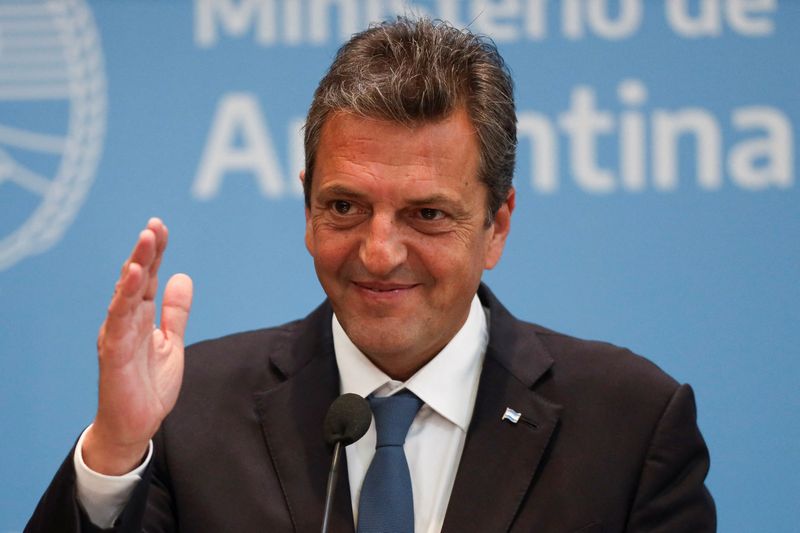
[73,295,489,533]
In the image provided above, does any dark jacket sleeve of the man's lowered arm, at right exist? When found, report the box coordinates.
[626,385,717,533]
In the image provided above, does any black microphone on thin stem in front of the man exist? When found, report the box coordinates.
[322,392,372,533]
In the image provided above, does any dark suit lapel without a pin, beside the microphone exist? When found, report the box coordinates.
[255,305,354,532]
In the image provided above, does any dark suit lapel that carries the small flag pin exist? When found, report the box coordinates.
[442,286,560,532]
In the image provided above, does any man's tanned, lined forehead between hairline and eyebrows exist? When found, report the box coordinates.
[312,109,480,196]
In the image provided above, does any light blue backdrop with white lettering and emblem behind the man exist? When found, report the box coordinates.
[0,0,800,533]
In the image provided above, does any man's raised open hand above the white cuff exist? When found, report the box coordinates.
[82,218,192,475]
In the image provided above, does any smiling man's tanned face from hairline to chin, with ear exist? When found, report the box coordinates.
[306,110,514,379]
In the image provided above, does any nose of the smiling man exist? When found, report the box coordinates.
[359,214,408,277]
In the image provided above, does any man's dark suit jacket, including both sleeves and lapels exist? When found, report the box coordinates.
[26,287,716,533]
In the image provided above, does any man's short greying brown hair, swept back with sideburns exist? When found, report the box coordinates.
[303,17,517,220]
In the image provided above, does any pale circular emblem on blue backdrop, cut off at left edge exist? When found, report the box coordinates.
[0,0,106,270]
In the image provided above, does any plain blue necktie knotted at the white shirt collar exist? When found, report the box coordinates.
[358,390,422,533]
